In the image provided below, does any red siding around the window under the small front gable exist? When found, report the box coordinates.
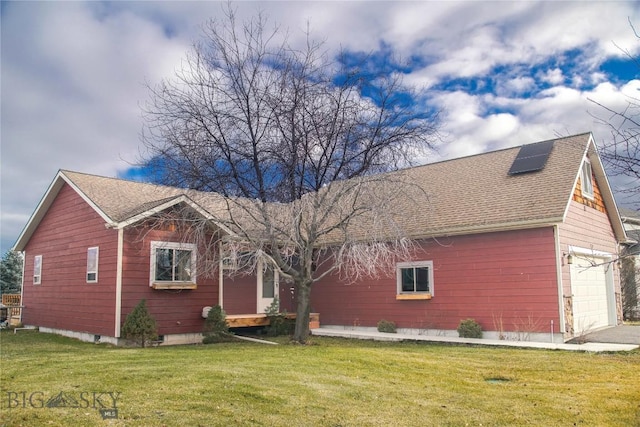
[121,229,218,335]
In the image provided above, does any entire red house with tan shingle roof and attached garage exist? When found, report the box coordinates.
[15,133,627,344]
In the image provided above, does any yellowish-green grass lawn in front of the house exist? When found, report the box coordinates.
[0,331,640,426]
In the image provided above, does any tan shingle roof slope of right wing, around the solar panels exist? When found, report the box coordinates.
[384,134,590,235]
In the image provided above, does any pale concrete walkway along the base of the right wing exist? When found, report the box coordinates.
[311,327,639,352]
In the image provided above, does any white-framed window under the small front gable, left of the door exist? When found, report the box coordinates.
[150,242,196,289]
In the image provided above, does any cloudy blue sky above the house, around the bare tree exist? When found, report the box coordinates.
[0,1,640,254]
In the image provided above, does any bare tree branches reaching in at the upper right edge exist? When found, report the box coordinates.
[590,21,640,202]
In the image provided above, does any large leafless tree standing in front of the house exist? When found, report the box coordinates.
[143,7,438,342]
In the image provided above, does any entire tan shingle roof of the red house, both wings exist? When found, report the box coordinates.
[16,133,621,249]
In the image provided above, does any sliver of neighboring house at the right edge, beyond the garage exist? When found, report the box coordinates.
[620,208,640,319]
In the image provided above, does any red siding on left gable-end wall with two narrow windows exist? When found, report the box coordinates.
[23,184,117,336]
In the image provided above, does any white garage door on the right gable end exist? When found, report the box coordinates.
[571,256,609,335]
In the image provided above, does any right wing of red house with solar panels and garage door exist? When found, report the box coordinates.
[312,134,626,341]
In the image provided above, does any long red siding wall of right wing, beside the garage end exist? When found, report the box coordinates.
[311,227,559,332]
